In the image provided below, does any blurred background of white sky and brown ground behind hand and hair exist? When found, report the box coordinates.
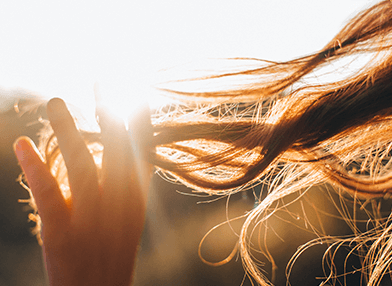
[0,0,382,286]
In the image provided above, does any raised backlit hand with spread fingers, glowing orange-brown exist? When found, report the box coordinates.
[14,98,152,286]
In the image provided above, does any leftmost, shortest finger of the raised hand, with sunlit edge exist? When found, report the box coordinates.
[14,137,69,227]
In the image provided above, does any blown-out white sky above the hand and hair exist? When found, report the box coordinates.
[0,0,377,119]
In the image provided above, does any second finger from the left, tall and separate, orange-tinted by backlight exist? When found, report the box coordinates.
[47,98,98,211]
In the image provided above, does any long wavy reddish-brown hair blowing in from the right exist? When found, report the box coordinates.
[36,1,392,285]
